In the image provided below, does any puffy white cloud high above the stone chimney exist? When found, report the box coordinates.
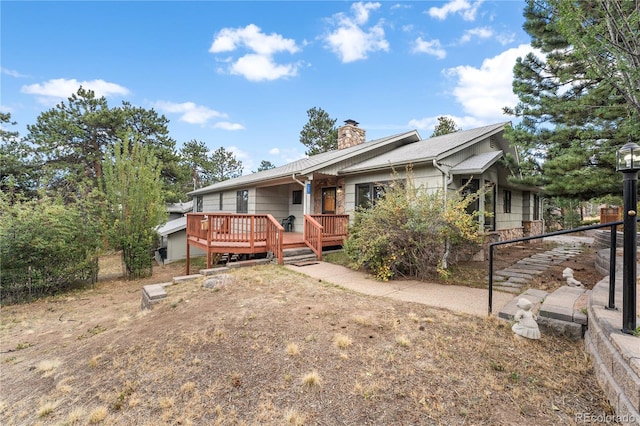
[324,2,389,63]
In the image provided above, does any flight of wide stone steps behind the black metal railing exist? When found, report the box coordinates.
[487,245,582,294]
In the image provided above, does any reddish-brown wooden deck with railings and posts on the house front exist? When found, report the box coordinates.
[187,212,349,273]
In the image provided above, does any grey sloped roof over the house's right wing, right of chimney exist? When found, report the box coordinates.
[342,122,509,173]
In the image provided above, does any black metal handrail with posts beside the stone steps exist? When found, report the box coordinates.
[489,219,640,315]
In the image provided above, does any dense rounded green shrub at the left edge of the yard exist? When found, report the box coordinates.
[0,198,101,303]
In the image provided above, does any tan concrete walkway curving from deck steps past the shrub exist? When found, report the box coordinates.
[286,262,513,316]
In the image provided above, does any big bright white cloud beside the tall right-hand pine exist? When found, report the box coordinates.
[445,44,532,123]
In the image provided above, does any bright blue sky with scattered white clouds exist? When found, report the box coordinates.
[0,0,531,173]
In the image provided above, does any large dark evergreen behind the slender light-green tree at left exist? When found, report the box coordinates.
[26,87,180,199]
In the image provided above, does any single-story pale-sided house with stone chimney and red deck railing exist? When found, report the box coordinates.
[187,120,542,268]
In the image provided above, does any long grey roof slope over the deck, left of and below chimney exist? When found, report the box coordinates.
[188,130,420,196]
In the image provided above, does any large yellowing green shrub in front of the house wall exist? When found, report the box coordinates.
[344,173,481,281]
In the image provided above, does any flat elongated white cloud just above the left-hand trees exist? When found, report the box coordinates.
[20,78,129,104]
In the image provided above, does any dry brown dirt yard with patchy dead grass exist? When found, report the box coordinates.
[0,243,610,425]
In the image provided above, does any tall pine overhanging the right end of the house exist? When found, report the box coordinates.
[505,0,633,200]
